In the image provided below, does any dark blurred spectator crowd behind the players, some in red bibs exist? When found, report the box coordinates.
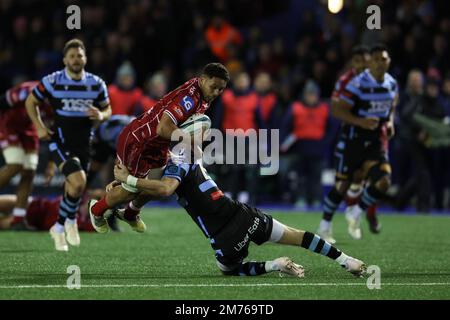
[0,0,450,212]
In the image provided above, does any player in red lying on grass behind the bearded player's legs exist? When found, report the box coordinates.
[0,189,104,232]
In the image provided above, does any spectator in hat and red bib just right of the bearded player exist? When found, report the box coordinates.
[108,61,143,116]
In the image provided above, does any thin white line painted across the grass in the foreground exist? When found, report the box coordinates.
[0,282,450,289]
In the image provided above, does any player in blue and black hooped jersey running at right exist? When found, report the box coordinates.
[319,45,398,240]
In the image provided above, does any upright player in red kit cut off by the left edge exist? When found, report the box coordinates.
[0,81,48,229]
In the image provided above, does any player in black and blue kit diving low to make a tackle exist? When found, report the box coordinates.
[108,158,365,277]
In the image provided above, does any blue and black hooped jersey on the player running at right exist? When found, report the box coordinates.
[340,69,398,139]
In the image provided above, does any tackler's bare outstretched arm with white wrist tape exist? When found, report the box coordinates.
[114,164,180,197]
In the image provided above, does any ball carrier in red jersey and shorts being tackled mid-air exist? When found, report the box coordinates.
[89,63,230,232]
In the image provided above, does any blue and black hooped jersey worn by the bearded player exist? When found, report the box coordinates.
[32,69,109,147]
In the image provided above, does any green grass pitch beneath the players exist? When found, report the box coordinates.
[0,208,450,300]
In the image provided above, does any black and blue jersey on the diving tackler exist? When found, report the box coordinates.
[163,162,239,238]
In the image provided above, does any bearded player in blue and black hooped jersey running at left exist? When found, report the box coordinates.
[26,39,111,251]
